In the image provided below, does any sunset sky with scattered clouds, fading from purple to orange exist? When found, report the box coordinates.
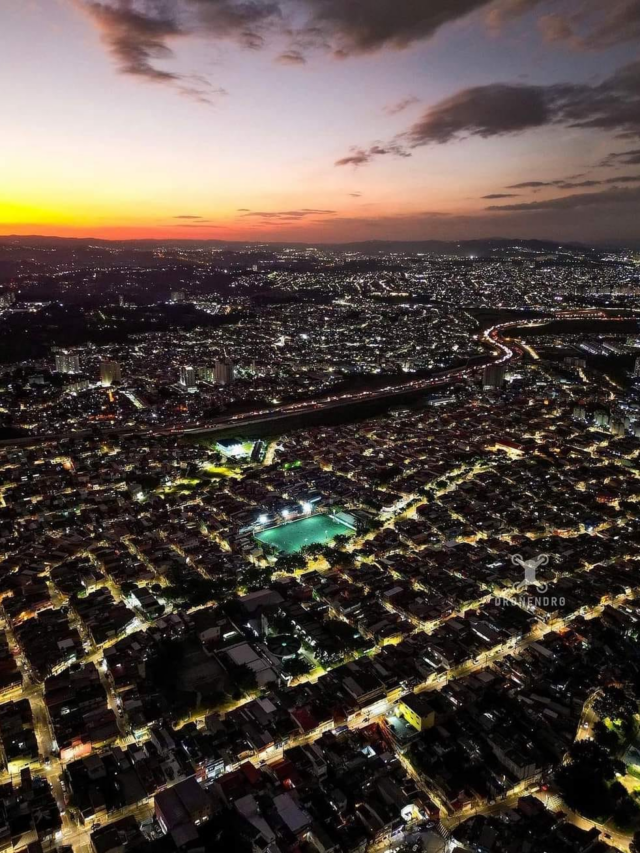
[0,0,640,243]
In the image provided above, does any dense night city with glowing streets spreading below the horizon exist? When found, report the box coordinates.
[0,238,640,853]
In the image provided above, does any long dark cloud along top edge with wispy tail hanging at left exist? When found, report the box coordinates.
[80,0,535,95]
